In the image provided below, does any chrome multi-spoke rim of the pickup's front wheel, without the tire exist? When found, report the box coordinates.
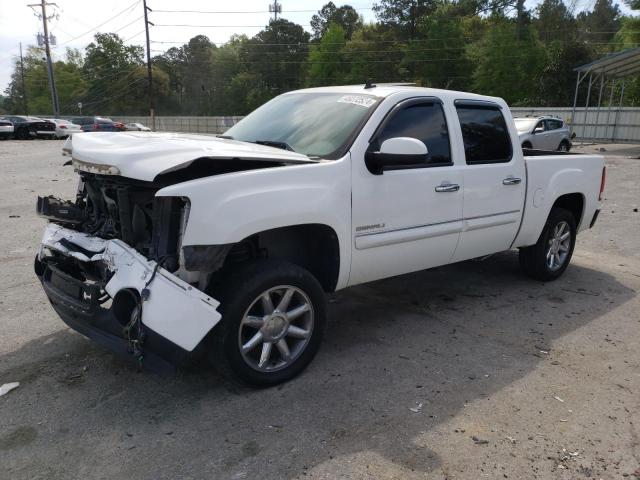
[238,285,314,372]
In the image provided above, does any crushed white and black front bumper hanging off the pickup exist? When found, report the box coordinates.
[35,223,221,370]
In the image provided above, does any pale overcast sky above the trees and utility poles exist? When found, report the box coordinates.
[0,0,629,93]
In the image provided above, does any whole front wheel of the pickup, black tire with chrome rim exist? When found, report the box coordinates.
[209,260,326,387]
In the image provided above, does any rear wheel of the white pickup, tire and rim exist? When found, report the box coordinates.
[519,208,576,282]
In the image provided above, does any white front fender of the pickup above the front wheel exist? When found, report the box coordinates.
[156,156,351,285]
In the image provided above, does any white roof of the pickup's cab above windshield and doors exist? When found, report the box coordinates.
[288,83,502,102]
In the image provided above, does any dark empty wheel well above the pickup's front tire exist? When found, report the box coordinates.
[225,223,340,292]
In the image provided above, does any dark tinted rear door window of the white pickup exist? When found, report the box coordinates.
[456,104,512,165]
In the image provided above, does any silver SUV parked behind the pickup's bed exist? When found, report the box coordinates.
[513,117,572,152]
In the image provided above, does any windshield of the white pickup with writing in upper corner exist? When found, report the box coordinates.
[224,93,380,158]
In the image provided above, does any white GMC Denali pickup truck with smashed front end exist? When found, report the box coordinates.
[35,85,605,385]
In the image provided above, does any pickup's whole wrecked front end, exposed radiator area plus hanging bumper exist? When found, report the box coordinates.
[35,171,221,370]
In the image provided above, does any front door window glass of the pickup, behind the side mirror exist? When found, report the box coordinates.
[375,102,451,167]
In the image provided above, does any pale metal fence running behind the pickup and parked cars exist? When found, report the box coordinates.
[113,107,640,143]
